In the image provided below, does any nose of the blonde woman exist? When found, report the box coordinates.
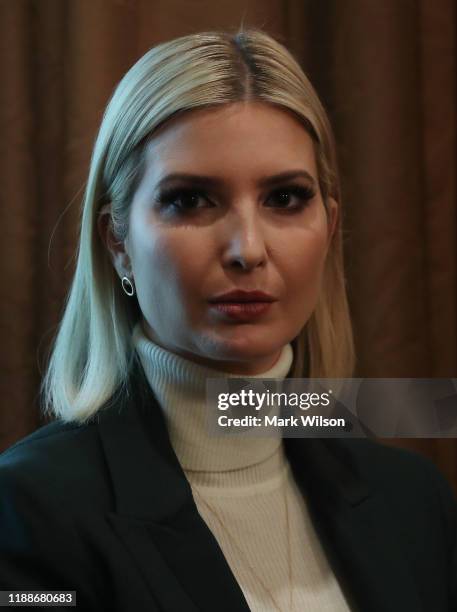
[223,206,267,270]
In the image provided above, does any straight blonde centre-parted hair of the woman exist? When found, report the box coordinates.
[41,28,354,423]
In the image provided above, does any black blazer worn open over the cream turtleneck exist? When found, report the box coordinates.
[0,360,457,612]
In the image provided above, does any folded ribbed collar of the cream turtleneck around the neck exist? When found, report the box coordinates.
[133,322,293,472]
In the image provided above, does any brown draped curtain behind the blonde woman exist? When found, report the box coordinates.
[0,0,457,490]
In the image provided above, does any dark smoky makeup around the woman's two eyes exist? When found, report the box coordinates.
[155,185,316,215]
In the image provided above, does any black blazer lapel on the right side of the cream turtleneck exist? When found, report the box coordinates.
[284,438,426,612]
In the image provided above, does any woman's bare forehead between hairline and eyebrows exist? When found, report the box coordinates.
[142,102,317,184]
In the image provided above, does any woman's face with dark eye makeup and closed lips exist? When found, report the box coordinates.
[100,103,337,376]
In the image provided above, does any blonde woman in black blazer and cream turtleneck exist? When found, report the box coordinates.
[0,29,457,612]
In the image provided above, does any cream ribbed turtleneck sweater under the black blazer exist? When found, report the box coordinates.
[133,323,349,612]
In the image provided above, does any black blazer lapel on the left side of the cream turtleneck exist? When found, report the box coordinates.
[97,358,249,612]
